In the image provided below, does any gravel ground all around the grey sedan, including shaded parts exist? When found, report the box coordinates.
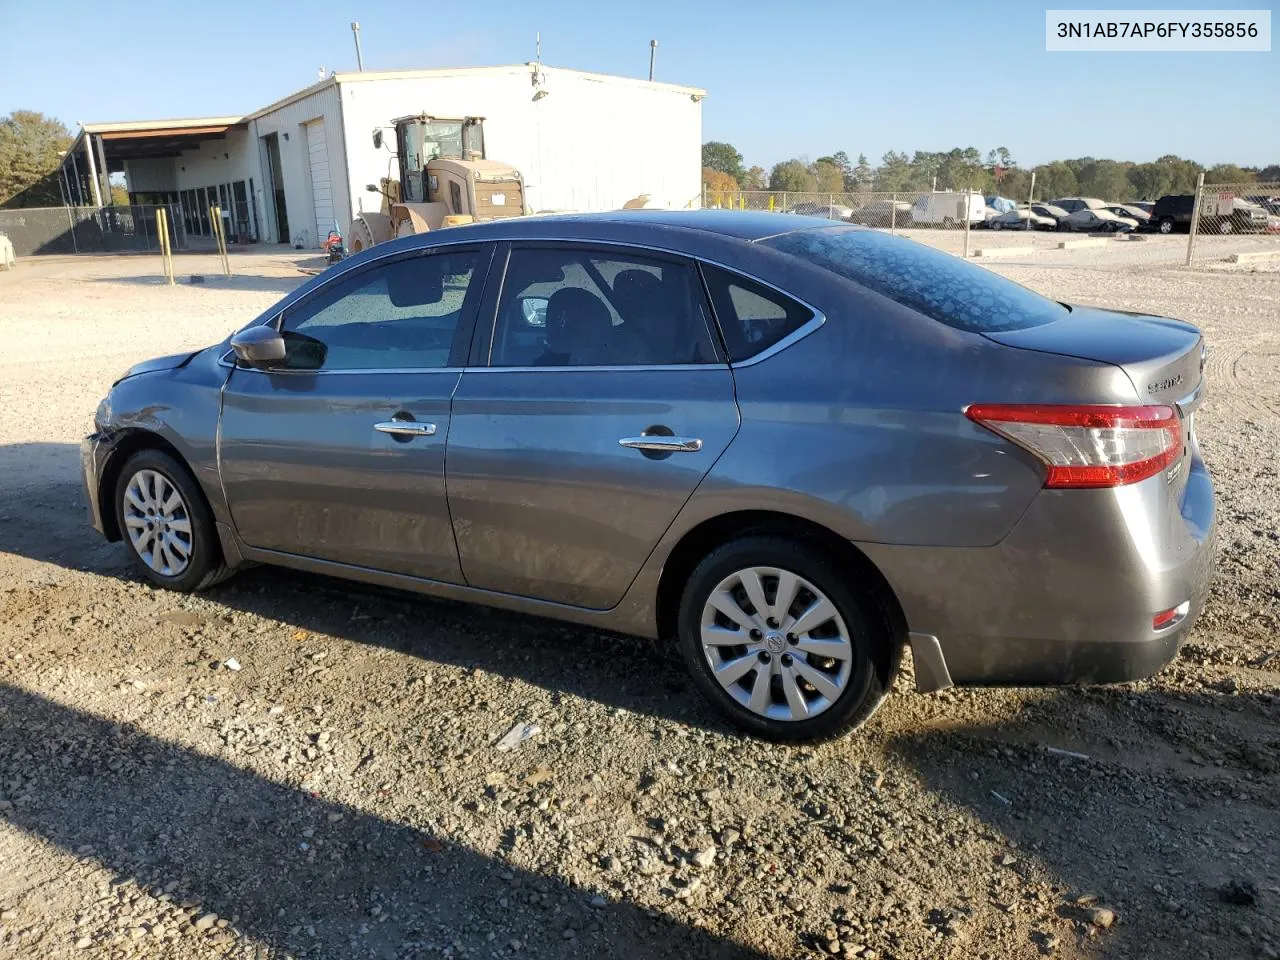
[0,245,1280,960]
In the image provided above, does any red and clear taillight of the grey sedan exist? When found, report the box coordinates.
[965,403,1183,488]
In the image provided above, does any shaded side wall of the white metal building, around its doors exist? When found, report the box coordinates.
[252,83,351,250]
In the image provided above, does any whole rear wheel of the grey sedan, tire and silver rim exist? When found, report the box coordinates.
[678,536,891,740]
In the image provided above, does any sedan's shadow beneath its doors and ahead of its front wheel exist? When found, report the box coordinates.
[0,443,728,732]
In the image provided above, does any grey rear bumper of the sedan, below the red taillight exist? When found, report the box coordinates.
[859,451,1215,686]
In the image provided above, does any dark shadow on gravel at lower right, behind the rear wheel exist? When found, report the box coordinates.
[887,686,1280,957]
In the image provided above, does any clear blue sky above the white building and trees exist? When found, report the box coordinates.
[0,0,1280,168]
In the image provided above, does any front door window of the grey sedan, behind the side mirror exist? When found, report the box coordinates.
[280,250,488,370]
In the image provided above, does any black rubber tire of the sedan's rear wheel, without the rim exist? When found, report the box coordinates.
[677,535,893,741]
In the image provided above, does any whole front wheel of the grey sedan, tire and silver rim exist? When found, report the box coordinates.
[115,449,229,591]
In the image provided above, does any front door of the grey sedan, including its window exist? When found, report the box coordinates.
[219,246,493,582]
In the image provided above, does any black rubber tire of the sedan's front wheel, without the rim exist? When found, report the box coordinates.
[113,449,232,593]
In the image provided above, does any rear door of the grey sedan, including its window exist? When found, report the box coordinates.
[448,244,739,609]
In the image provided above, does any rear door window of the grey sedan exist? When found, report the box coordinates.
[489,247,717,366]
